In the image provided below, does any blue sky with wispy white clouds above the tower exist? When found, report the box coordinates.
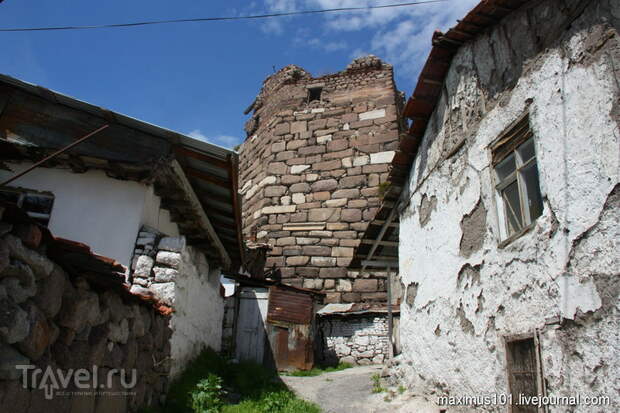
[0,0,478,147]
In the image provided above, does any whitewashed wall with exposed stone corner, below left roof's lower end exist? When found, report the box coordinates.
[131,227,224,377]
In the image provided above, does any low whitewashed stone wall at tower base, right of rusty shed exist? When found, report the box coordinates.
[320,315,390,365]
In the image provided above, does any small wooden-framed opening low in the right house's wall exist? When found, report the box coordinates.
[506,334,544,413]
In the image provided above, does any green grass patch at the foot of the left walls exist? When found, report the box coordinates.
[151,350,320,413]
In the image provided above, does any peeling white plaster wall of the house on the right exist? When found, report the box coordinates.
[397,0,620,412]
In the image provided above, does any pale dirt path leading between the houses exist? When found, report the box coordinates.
[281,366,439,413]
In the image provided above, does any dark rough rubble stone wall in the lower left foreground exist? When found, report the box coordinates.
[0,207,172,413]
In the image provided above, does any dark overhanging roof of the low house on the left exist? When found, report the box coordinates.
[0,75,242,263]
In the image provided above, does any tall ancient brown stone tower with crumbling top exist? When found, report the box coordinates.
[240,56,402,302]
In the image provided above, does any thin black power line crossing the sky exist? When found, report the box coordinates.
[0,0,448,32]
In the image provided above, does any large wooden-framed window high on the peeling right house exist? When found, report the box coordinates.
[491,113,543,240]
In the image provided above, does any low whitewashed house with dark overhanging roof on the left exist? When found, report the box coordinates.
[0,76,241,375]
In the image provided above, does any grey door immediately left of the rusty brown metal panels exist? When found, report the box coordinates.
[236,287,269,363]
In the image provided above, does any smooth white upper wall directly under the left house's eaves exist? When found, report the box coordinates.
[0,163,178,266]
